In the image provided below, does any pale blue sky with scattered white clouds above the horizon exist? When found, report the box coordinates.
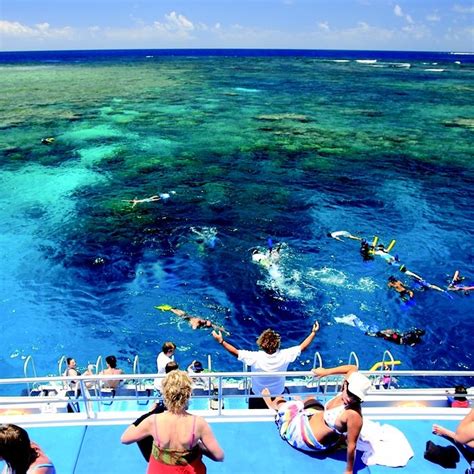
[0,0,474,52]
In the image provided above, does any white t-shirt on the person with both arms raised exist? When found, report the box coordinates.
[238,346,301,395]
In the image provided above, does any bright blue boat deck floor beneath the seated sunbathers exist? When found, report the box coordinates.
[0,419,468,474]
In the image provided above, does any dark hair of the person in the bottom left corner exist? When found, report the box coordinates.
[0,425,38,474]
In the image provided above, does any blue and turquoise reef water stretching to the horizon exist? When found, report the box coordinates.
[0,51,474,382]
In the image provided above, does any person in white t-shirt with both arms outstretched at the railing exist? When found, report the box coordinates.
[212,321,319,409]
